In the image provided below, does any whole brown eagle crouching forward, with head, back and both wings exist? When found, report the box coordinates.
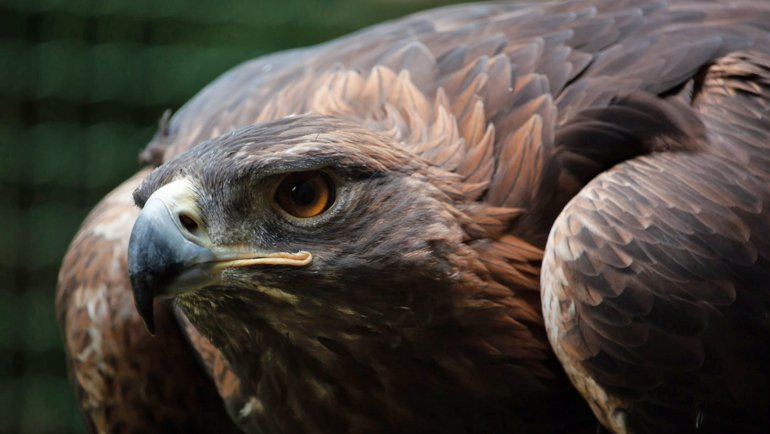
[57,0,770,433]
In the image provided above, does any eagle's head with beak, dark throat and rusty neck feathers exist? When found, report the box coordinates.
[129,116,549,427]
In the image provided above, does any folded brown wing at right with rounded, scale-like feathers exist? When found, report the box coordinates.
[541,50,770,432]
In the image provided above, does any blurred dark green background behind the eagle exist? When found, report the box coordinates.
[0,0,472,433]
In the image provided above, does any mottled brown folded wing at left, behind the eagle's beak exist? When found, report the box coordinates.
[56,170,239,433]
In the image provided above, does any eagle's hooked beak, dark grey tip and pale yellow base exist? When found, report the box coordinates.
[128,179,312,334]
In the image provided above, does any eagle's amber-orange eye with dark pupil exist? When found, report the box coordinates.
[273,171,335,218]
